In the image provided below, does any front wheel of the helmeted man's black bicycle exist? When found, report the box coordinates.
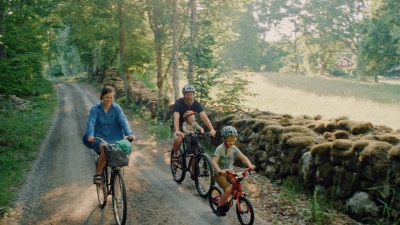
[194,153,215,197]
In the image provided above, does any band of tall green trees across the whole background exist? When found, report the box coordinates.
[0,0,400,101]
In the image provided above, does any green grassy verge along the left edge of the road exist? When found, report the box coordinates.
[0,81,57,214]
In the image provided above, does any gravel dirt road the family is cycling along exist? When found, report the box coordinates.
[2,83,267,225]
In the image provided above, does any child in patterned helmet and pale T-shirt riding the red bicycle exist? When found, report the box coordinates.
[212,126,256,216]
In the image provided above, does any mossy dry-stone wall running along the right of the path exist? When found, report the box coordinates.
[211,111,400,224]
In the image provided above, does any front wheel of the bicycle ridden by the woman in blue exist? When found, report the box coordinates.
[112,169,127,225]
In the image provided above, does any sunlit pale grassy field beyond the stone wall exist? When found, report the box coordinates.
[246,73,400,130]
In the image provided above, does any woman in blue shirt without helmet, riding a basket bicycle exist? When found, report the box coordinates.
[82,86,136,184]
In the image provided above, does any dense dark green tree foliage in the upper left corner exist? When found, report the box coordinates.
[0,2,53,96]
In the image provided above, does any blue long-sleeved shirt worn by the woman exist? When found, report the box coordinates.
[85,102,133,144]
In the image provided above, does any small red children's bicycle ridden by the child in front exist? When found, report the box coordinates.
[208,168,254,225]
